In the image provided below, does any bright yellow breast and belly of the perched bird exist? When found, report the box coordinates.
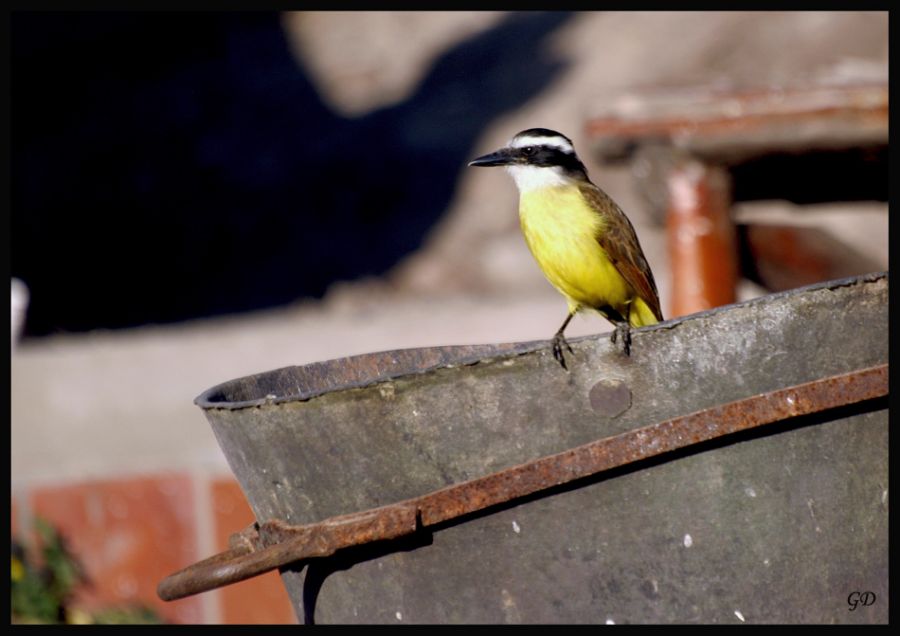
[519,186,634,316]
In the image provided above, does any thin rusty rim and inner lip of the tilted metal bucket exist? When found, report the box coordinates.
[194,272,888,411]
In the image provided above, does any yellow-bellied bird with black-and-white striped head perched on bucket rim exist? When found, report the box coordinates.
[469,128,663,369]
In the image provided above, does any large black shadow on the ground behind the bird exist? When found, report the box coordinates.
[11,12,570,336]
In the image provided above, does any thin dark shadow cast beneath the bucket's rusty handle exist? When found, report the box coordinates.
[291,396,888,624]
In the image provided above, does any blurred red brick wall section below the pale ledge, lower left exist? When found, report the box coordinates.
[11,473,297,624]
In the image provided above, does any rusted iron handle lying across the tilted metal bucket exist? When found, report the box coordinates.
[157,364,888,601]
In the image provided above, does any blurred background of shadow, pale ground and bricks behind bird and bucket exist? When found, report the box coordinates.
[10,11,888,623]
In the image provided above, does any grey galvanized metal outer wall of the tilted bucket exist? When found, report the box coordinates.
[192,274,888,622]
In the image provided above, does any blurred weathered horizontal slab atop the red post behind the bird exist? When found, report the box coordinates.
[586,83,889,160]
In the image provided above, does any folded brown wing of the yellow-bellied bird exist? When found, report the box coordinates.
[579,183,663,321]
